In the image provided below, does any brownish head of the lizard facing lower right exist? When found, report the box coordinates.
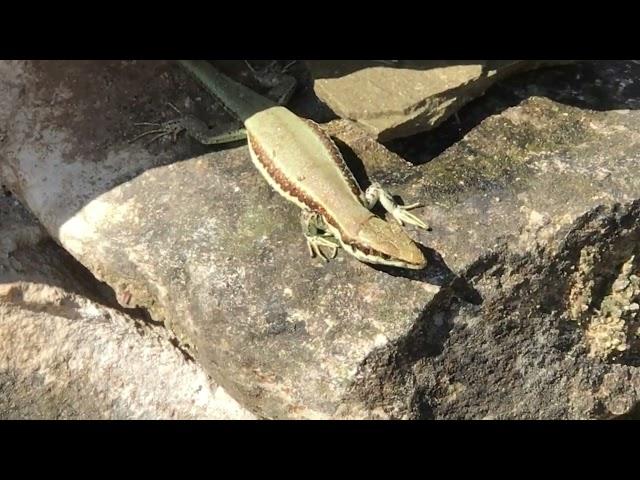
[341,217,427,270]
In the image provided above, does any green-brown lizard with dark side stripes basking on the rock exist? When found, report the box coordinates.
[134,60,428,269]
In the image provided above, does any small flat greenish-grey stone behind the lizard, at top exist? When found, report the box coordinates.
[306,60,568,141]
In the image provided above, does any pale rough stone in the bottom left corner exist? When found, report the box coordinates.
[0,198,253,419]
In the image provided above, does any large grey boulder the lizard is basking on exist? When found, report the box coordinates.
[0,62,640,418]
